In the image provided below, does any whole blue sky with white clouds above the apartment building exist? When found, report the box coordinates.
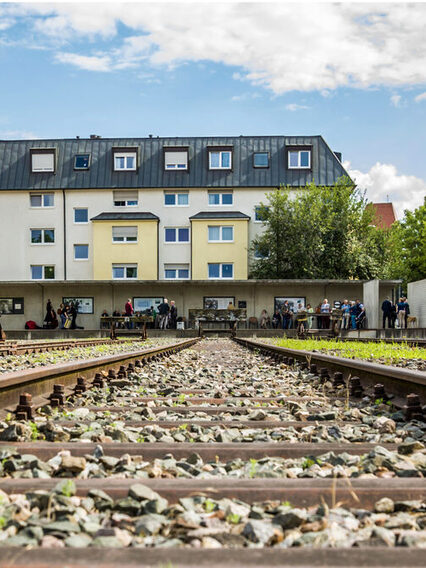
[0,2,426,215]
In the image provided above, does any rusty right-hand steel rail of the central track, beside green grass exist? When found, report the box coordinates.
[234,337,426,404]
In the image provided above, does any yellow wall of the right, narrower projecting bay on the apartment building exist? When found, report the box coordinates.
[191,219,248,280]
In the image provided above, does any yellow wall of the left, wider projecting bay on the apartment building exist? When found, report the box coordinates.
[93,220,158,280]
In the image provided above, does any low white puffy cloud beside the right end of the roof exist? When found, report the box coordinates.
[343,162,426,219]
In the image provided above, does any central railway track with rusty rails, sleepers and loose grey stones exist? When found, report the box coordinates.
[0,340,426,568]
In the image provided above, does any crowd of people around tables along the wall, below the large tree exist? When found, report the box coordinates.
[260,298,365,329]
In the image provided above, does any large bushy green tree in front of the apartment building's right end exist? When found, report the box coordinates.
[251,178,387,278]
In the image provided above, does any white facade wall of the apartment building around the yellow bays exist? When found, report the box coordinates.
[0,188,272,281]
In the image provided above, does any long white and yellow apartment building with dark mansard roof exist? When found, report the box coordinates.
[0,136,398,326]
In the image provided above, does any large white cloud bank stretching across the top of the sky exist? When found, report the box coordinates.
[5,2,426,94]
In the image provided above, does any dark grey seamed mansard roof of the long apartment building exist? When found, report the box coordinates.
[0,136,348,190]
